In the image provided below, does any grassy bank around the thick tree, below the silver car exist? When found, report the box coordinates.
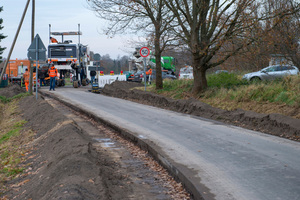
[148,73,300,118]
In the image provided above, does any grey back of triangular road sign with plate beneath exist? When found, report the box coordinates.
[27,34,46,61]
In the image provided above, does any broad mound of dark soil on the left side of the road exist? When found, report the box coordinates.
[5,96,136,200]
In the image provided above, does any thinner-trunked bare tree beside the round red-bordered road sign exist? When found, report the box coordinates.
[88,0,173,89]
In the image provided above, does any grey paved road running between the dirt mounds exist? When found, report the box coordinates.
[42,88,300,200]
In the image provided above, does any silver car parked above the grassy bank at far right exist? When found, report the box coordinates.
[243,65,299,81]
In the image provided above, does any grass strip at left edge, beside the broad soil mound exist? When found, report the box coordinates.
[0,94,34,195]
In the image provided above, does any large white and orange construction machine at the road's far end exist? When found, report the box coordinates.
[48,24,90,88]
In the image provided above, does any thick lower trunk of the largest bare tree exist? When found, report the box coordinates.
[192,55,207,95]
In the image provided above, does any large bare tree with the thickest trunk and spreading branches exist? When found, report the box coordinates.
[165,0,298,94]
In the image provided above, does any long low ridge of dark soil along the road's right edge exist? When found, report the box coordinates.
[102,81,300,141]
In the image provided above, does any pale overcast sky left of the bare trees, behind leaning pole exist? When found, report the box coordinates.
[0,0,134,59]
